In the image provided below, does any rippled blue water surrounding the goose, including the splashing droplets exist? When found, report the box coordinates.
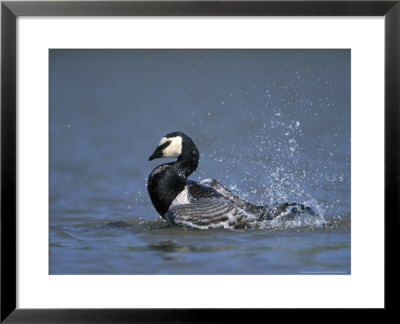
[49,50,351,274]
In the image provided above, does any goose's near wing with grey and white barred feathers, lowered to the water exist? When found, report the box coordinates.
[165,196,255,229]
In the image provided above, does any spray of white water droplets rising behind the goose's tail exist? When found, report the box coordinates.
[220,85,340,228]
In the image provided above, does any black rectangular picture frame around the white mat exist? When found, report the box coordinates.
[1,0,400,323]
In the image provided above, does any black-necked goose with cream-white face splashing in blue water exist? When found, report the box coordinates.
[147,132,315,229]
